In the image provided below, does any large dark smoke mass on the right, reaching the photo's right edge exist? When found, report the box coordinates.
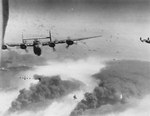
[70,61,150,116]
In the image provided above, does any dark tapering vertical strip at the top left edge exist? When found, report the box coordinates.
[2,0,9,42]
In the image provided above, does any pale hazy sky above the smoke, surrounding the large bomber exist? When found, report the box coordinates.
[2,0,150,60]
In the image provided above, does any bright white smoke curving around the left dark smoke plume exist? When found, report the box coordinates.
[1,57,105,116]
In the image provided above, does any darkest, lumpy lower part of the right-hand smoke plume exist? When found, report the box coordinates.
[71,82,124,116]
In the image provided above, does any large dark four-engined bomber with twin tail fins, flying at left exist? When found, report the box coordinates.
[2,32,101,56]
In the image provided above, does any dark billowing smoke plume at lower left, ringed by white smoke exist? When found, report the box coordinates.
[9,75,81,112]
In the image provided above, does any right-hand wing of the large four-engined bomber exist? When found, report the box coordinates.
[55,35,102,44]
